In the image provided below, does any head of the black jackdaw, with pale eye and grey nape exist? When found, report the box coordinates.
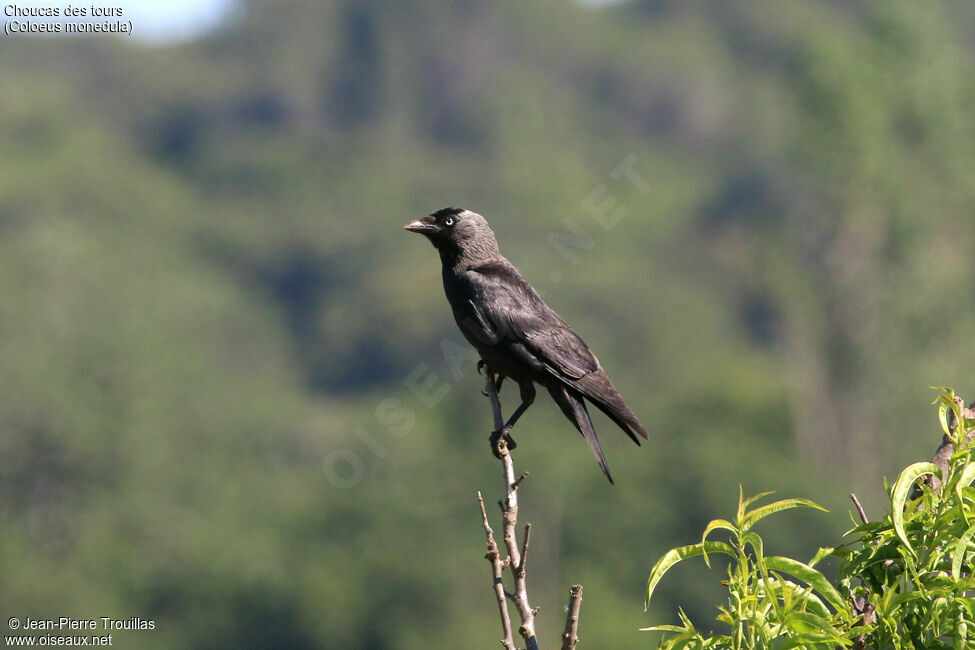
[403,208,500,260]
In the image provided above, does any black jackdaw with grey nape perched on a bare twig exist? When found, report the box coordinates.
[403,207,647,483]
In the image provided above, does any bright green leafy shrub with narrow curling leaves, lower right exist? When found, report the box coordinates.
[646,389,975,650]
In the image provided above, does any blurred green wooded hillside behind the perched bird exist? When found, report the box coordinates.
[0,0,975,650]
